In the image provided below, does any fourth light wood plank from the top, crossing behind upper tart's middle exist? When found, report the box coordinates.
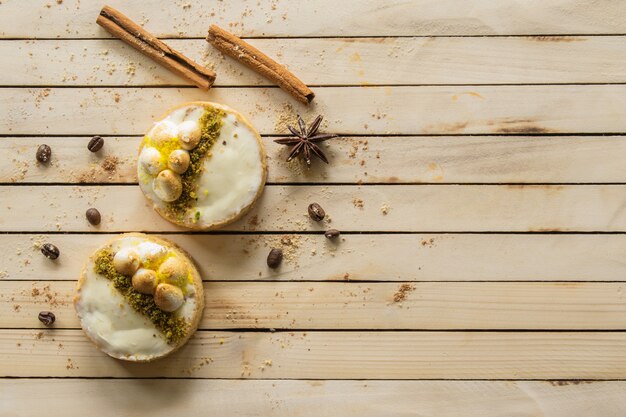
[0,136,626,184]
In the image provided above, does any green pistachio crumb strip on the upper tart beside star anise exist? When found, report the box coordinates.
[168,107,226,221]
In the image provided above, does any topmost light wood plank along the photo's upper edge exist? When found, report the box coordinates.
[0,0,626,38]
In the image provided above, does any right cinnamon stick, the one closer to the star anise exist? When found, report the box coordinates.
[207,25,315,104]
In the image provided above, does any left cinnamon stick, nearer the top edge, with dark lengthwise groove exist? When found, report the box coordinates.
[96,6,215,90]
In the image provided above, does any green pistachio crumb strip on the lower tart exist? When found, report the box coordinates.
[94,248,189,343]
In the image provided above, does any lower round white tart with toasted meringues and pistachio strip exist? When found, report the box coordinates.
[74,233,204,362]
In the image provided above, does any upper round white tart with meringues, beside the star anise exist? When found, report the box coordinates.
[137,101,267,230]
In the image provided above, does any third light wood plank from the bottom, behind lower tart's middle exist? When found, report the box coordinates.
[0,281,626,330]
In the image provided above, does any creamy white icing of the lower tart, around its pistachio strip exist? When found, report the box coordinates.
[74,233,204,361]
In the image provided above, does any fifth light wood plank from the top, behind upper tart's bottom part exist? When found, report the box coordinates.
[0,185,626,232]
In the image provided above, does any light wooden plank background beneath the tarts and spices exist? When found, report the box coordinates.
[0,0,626,417]
